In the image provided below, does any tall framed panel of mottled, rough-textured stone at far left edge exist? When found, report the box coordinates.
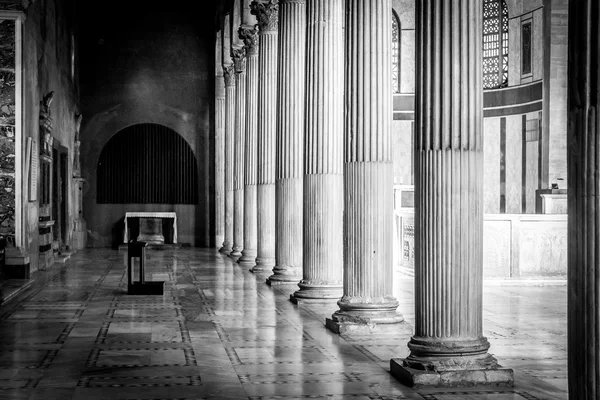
[0,20,16,242]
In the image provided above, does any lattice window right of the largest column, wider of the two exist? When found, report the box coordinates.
[483,0,508,89]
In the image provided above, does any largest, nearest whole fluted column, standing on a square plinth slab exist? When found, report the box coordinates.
[390,0,513,387]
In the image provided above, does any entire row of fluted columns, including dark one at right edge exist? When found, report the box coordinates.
[215,0,600,399]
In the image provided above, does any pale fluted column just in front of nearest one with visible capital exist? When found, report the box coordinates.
[267,0,306,285]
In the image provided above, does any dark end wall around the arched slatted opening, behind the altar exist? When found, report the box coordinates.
[81,1,215,247]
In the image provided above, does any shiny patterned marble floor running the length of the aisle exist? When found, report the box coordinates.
[0,248,567,400]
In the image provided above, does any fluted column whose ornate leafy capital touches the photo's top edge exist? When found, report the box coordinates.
[250,0,278,272]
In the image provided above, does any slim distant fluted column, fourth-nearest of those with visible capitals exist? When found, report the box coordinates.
[221,65,235,254]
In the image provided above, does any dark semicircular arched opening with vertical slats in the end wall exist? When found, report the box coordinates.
[97,124,198,204]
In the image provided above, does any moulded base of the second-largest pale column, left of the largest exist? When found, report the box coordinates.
[325,303,404,335]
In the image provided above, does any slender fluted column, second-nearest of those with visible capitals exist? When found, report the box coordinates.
[238,25,258,267]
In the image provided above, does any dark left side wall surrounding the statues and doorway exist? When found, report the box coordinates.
[19,0,79,271]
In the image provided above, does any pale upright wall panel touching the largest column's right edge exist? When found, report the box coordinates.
[483,118,500,214]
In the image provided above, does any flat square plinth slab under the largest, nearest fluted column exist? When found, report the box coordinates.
[390,358,514,387]
